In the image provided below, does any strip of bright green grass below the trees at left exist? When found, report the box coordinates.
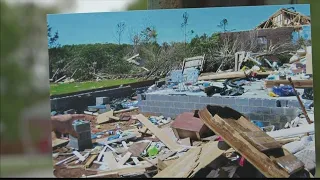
[50,79,139,95]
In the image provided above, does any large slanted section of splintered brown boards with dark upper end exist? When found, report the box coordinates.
[199,106,300,178]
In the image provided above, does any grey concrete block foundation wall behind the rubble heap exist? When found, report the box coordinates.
[138,94,310,128]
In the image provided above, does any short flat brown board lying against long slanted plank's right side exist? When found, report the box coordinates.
[241,130,282,152]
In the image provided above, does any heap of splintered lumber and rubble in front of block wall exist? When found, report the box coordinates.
[53,105,315,178]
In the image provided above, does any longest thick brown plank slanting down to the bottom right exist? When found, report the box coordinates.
[199,108,290,178]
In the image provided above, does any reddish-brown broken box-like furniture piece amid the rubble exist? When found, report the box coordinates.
[171,112,211,140]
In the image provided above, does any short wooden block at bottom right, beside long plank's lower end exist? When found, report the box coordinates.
[275,154,304,175]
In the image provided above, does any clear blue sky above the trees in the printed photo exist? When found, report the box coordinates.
[47,4,310,45]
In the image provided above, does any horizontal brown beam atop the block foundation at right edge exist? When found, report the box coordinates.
[264,79,313,88]
